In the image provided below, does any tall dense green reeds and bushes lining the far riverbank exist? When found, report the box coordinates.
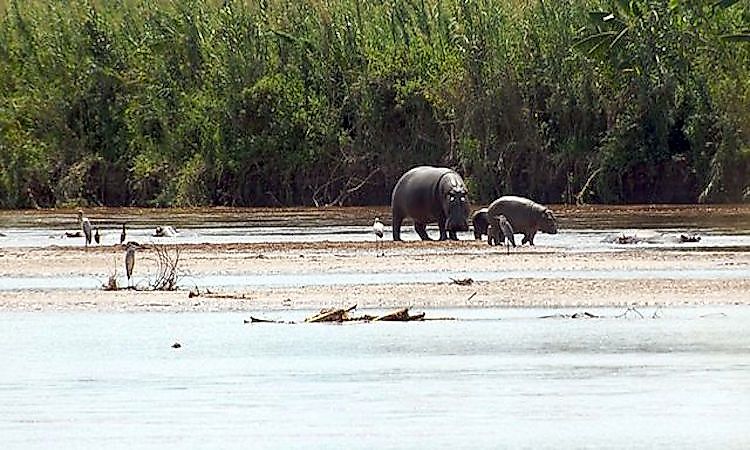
[0,0,750,208]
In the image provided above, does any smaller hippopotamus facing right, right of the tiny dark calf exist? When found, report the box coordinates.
[487,195,557,245]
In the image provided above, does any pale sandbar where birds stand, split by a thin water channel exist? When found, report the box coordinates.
[0,241,750,312]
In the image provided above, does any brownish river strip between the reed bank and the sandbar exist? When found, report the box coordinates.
[0,205,750,251]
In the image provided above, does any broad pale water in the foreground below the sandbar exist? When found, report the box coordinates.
[0,307,750,449]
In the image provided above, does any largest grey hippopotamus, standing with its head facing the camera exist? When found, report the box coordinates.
[391,166,469,241]
